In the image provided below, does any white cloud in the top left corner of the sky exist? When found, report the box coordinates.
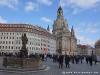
[0,0,19,9]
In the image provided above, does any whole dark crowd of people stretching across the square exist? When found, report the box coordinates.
[0,53,97,68]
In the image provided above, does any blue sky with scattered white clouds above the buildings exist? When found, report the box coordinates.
[0,0,100,47]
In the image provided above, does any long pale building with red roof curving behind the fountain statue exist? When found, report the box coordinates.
[0,23,56,55]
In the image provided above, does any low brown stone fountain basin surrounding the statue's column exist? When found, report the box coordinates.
[3,58,42,68]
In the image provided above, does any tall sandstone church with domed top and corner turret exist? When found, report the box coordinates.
[52,6,77,55]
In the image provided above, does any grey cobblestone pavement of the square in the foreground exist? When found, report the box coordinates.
[0,57,100,75]
